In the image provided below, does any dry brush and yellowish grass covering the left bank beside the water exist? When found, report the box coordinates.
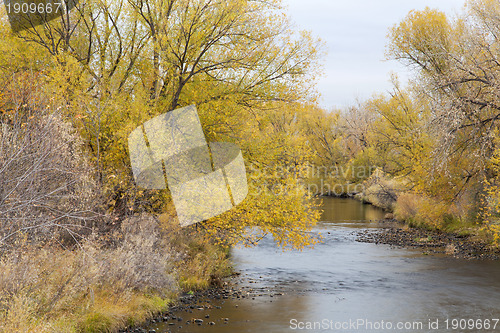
[0,215,231,333]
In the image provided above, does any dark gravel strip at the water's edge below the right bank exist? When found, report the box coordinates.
[356,220,500,260]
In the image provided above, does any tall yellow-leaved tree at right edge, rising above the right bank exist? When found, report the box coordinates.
[388,1,500,228]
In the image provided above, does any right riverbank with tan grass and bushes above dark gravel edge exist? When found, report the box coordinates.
[322,169,500,260]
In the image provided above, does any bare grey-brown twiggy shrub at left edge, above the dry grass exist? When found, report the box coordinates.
[0,105,97,245]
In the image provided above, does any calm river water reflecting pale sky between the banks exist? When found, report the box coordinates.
[151,198,500,333]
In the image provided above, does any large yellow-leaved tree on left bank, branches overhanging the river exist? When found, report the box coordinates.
[0,0,321,245]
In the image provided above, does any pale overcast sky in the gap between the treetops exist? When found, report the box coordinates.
[283,0,465,109]
